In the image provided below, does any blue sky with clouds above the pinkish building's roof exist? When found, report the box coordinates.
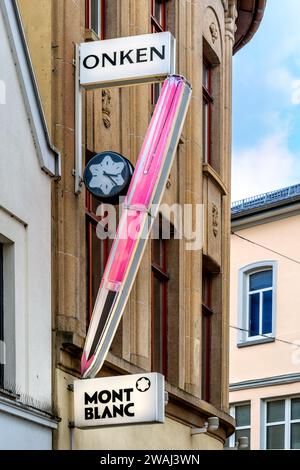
[232,0,300,201]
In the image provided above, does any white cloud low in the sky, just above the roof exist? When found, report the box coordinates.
[232,132,300,201]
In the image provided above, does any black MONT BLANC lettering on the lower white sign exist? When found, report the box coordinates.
[84,388,135,420]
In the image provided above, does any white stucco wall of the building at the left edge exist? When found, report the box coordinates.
[0,8,51,448]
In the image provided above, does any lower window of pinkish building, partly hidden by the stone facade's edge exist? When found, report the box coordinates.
[225,403,251,450]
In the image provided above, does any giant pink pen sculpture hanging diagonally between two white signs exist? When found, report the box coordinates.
[81,75,191,378]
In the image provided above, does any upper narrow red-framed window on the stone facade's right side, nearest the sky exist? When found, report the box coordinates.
[202,61,214,164]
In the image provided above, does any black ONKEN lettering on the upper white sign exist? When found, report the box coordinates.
[83,45,166,70]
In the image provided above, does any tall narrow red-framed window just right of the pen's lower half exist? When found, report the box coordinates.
[151,238,169,377]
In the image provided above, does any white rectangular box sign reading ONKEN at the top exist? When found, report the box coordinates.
[80,32,175,88]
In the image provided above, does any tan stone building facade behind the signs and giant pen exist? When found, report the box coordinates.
[19,0,265,449]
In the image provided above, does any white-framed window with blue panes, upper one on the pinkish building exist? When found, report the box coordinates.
[238,262,276,343]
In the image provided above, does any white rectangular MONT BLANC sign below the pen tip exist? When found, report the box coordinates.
[74,373,165,428]
